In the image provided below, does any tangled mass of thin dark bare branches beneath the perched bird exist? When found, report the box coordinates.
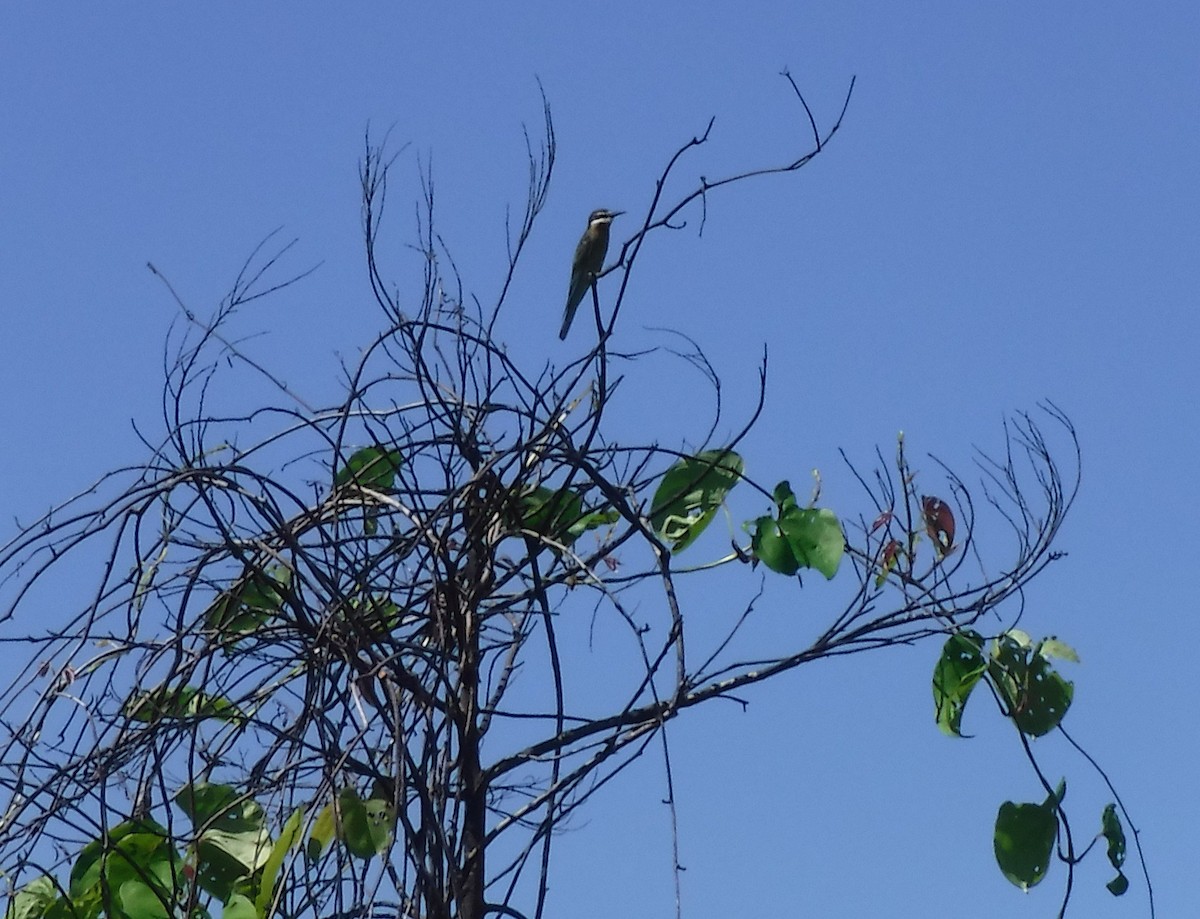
[0,75,1123,919]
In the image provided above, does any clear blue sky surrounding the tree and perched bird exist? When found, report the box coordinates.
[0,1,1200,919]
